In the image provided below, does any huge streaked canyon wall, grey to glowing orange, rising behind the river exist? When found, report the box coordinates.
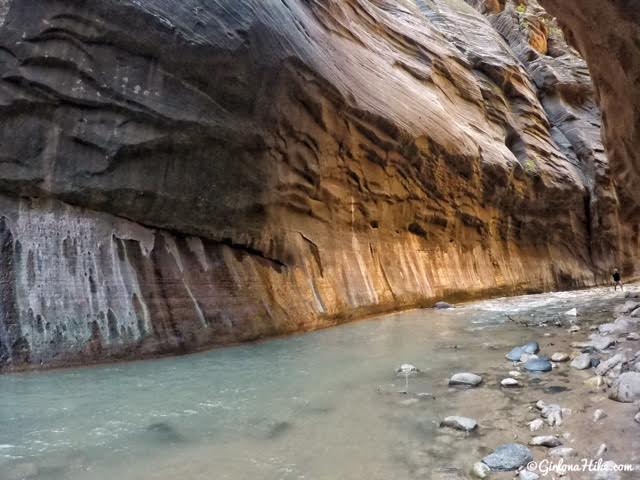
[0,0,638,368]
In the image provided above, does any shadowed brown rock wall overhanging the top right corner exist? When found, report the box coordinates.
[541,0,640,221]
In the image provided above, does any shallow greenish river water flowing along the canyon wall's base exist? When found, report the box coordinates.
[0,290,619,480]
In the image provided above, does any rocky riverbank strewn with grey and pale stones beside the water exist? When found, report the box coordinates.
[401,286,640,480]
